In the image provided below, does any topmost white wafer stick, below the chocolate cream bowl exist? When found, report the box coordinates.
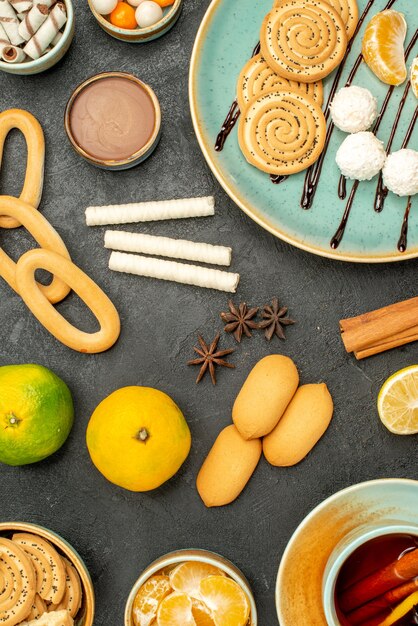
[86,196,215,226]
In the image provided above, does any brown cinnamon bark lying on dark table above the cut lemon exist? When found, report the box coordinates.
[340,297,418,359]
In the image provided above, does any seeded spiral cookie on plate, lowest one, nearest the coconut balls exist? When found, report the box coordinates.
[238,90,326,175]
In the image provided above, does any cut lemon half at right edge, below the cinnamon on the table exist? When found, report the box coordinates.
[377,365,418,435]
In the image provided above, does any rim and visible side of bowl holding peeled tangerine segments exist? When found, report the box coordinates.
[124,550,257,626]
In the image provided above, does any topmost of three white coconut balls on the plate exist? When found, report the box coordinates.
[330,85,377,133]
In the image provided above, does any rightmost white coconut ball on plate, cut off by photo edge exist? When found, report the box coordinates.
[383,148,418,196]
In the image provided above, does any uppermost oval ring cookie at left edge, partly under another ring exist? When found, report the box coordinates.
[0,109,45,228]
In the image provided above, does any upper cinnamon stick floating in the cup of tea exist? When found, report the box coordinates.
[340,549,418,613]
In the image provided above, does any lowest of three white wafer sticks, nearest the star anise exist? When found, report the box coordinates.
[109,252,239,293]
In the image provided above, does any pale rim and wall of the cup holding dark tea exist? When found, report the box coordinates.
[322,520,418,626]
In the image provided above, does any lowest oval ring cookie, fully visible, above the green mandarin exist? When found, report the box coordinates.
[16,248,120,354]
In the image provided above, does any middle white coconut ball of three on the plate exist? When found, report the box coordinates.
[335,132,386,180]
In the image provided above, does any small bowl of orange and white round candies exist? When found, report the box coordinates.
[88,0,183,43]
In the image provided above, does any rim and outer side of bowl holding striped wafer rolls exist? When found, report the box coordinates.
[0,0,75,76]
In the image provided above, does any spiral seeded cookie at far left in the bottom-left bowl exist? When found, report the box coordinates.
[0,537,36,626]
